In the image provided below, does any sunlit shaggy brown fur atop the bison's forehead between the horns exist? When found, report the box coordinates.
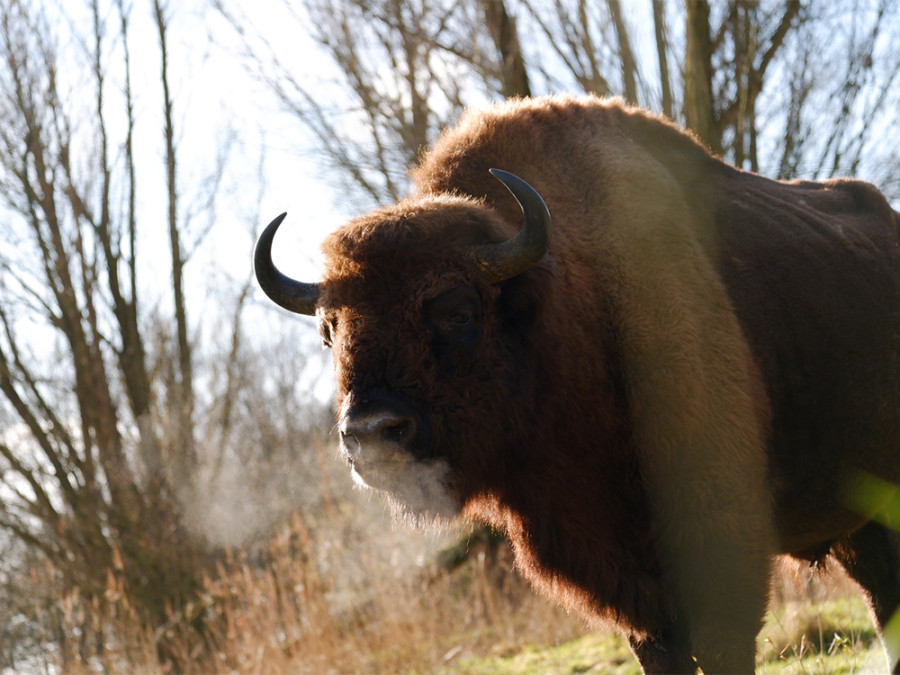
[322,195,511,281]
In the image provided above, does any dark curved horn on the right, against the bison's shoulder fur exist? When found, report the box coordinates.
[472,169,552,283]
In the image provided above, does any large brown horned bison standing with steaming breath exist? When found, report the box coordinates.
[255,98,900,673]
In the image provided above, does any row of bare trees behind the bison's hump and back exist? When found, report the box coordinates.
[236,0,900,201]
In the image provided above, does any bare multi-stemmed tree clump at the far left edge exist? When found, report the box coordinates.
[0,0,229,655]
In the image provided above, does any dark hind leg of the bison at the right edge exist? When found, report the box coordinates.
[831,521,900,673]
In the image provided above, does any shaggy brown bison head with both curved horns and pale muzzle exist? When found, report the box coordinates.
[254,170,550,521]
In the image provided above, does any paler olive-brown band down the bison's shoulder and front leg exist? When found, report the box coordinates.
[609,199,775,675]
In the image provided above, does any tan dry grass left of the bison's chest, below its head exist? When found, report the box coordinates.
[35,515,586,675]
